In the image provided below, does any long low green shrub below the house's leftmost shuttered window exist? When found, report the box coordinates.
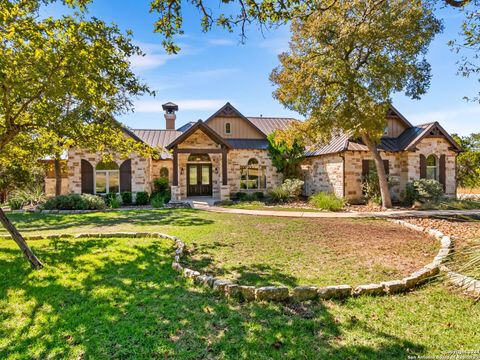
[42,194,105,210]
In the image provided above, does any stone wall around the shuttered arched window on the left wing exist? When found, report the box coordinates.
[67,149,151,194]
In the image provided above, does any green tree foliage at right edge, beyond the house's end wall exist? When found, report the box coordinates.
[453,133,480,188]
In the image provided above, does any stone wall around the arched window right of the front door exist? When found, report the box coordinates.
[228,149,283,194]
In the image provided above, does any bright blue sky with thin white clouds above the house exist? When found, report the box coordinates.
[44,0,480,135]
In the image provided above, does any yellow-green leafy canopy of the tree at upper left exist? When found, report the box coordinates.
[0,0,153,163]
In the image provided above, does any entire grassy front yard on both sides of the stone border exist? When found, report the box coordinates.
[0,210,480,359]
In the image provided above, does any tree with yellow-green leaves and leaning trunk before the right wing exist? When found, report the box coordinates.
[270,0,441,208]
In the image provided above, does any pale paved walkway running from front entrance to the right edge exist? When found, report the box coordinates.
[192,202,480,218]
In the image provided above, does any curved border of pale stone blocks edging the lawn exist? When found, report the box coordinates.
[0,220,464,301]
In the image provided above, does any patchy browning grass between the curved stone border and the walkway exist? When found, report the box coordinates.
[0,210,438,286]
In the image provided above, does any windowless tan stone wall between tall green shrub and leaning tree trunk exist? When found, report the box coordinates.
[302,154,344,197]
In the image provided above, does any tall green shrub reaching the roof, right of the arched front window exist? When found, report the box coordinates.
[267,130,305,178]
